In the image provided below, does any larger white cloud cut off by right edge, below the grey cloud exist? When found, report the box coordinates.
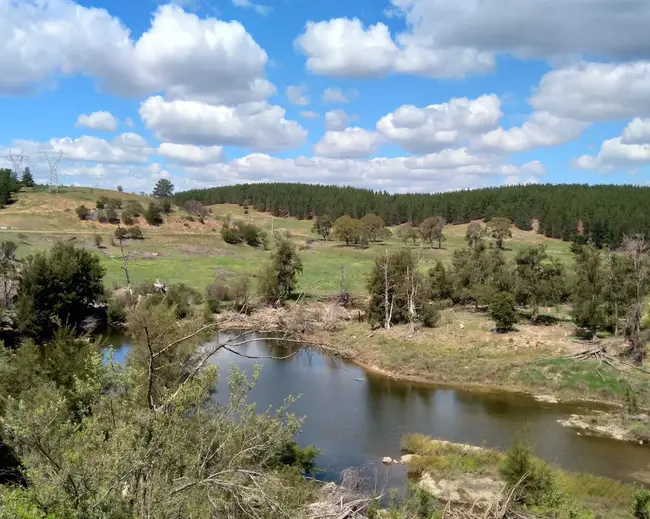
[530,61,650,122]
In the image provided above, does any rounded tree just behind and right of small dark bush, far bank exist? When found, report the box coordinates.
[515,245,566,319]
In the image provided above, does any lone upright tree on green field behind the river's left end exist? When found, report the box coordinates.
[258,236,303,304]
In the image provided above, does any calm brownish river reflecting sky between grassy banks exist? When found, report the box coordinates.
[109,340,650,486]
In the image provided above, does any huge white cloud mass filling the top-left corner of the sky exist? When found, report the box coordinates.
[0,0,275,103]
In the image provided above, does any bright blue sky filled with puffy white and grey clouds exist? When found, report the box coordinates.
[0,0,650,192]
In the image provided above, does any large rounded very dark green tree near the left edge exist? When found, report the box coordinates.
[16,243,104,340]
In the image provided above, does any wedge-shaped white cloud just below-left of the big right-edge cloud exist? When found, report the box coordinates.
[474,112,588,153]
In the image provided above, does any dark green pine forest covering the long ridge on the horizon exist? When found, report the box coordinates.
[175,183,650,247]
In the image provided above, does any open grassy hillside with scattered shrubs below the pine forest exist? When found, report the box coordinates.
[0,188,570,296]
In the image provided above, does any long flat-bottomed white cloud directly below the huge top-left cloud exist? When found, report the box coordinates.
[140,96,307,151]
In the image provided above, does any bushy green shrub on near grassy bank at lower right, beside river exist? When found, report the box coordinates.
[499,438,553,505]
